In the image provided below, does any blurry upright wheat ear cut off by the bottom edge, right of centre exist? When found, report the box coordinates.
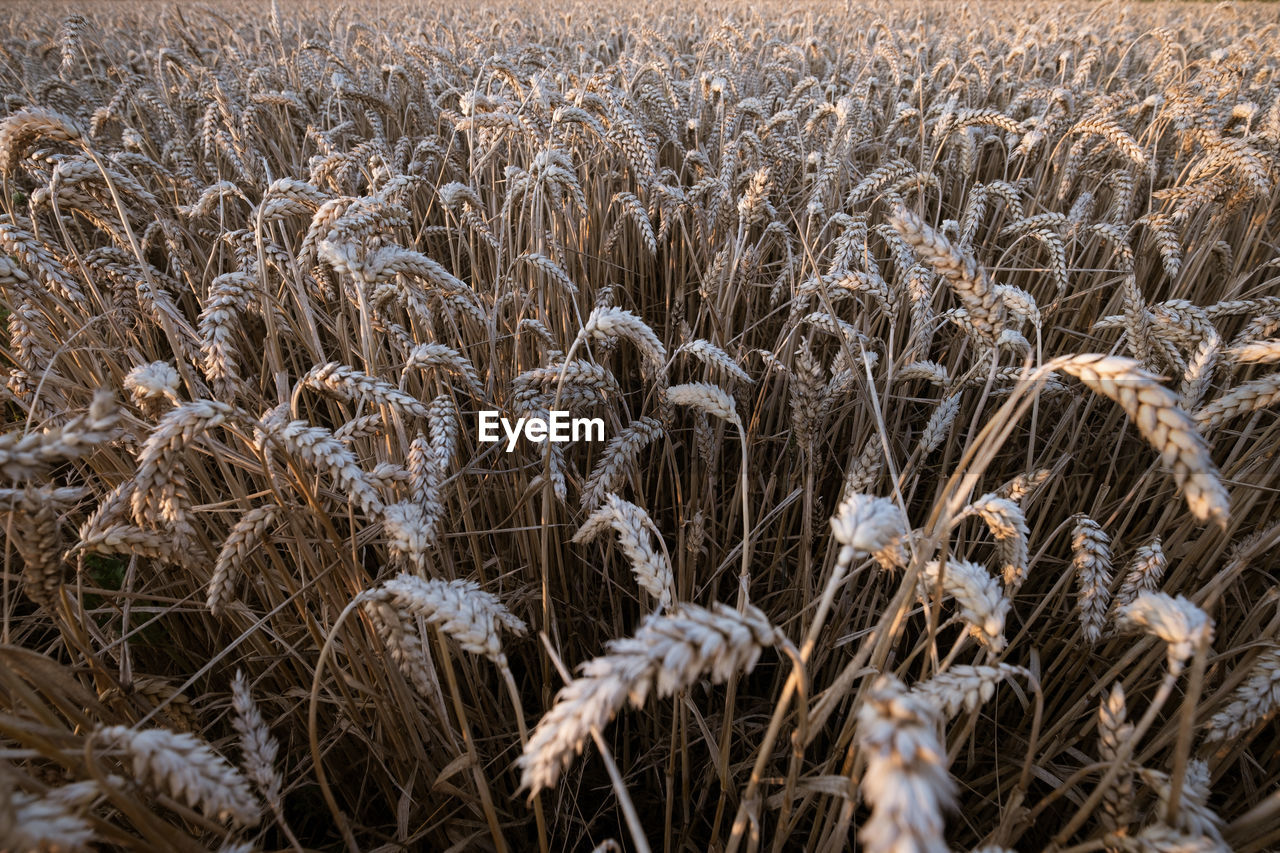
[858,675,956,853]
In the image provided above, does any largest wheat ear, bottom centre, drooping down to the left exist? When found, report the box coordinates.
[516,603,778,795]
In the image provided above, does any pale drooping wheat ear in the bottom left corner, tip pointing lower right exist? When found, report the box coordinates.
[93,726,260,826]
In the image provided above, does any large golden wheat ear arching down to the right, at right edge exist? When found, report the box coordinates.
[1052,353,1230,528]
